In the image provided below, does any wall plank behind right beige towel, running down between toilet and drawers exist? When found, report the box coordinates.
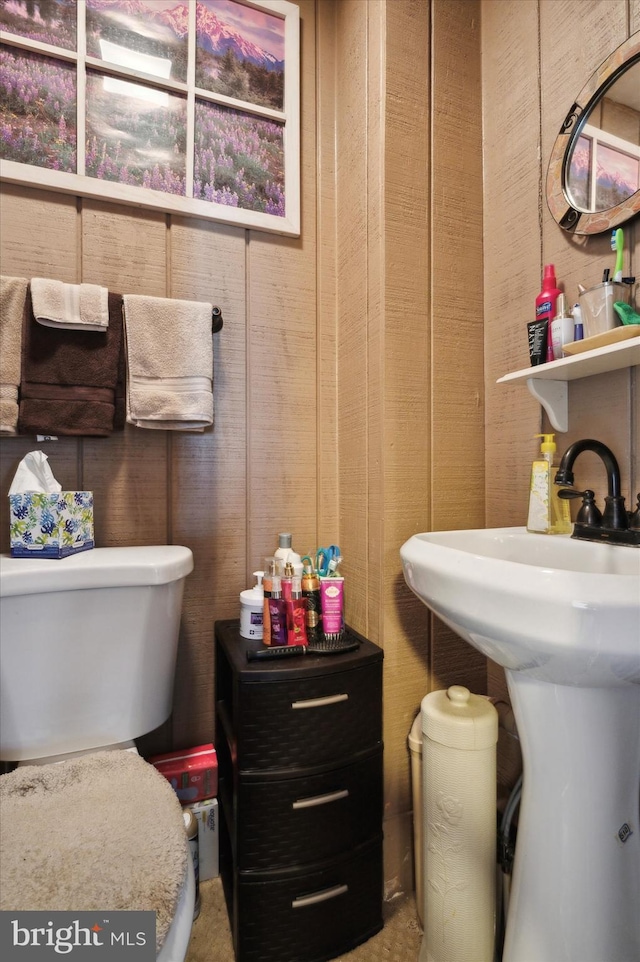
[169,218,246,745]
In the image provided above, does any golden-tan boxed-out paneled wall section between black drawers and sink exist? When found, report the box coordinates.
[318,0,486,893]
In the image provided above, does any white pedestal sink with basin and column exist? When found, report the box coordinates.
[400,528,640,962]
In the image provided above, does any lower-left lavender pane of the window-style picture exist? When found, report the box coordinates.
[0,48,76,173]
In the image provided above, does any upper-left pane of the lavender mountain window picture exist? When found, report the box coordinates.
[0,0,77,50]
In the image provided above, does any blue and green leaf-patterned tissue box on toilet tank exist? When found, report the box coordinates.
[9,491,93,558]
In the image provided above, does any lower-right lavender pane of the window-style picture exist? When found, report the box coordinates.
[193,100,285,217]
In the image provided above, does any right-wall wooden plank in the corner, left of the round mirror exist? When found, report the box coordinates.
[481,0,542,527]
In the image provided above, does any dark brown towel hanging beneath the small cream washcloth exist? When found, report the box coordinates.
[18,293,124,437]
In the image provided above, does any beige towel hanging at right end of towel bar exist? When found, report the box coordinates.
[123,294,213,431]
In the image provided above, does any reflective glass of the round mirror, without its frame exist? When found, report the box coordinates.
[565,62,640,213]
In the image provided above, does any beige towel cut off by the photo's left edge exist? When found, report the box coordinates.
[0,276,29,435]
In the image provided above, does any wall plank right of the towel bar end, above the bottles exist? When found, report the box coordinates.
[247,0,318,570]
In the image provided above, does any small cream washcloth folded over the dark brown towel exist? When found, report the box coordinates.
[31,277,109,332]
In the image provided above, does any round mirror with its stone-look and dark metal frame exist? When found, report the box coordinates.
[547,33,640,234]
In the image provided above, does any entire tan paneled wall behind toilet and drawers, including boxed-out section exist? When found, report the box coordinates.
[0,0,485,893]
